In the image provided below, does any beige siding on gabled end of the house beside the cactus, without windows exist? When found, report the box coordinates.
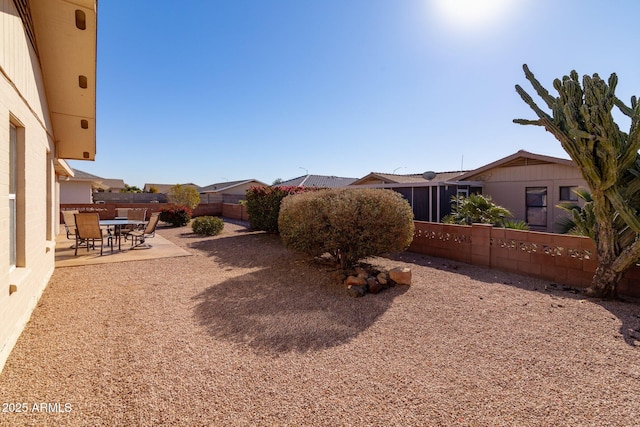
[468,163,588,232]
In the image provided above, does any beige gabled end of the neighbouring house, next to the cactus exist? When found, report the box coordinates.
[459,150,589,232]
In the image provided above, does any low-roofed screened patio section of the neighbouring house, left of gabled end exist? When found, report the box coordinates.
[351,171,482,222]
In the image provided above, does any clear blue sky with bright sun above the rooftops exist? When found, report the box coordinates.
[70,0,640,187]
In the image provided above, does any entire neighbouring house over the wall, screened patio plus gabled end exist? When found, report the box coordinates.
[352,150,588,232]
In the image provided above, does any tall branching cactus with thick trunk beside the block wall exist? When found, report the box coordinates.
[514,64,640,298]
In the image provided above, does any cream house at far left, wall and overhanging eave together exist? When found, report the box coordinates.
[0,0,97,370]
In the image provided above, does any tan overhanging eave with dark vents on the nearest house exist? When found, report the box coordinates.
[28,0,97,160]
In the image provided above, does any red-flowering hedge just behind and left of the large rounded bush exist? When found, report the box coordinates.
[245,187,317,233]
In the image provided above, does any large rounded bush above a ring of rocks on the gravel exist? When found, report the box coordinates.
[278,188,414,269]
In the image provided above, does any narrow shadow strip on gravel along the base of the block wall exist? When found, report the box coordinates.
[388,251,640,347]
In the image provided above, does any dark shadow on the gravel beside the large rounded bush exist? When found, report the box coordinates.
[190,233,407,355]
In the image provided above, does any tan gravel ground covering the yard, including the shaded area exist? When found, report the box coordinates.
[0,223,640,426]
